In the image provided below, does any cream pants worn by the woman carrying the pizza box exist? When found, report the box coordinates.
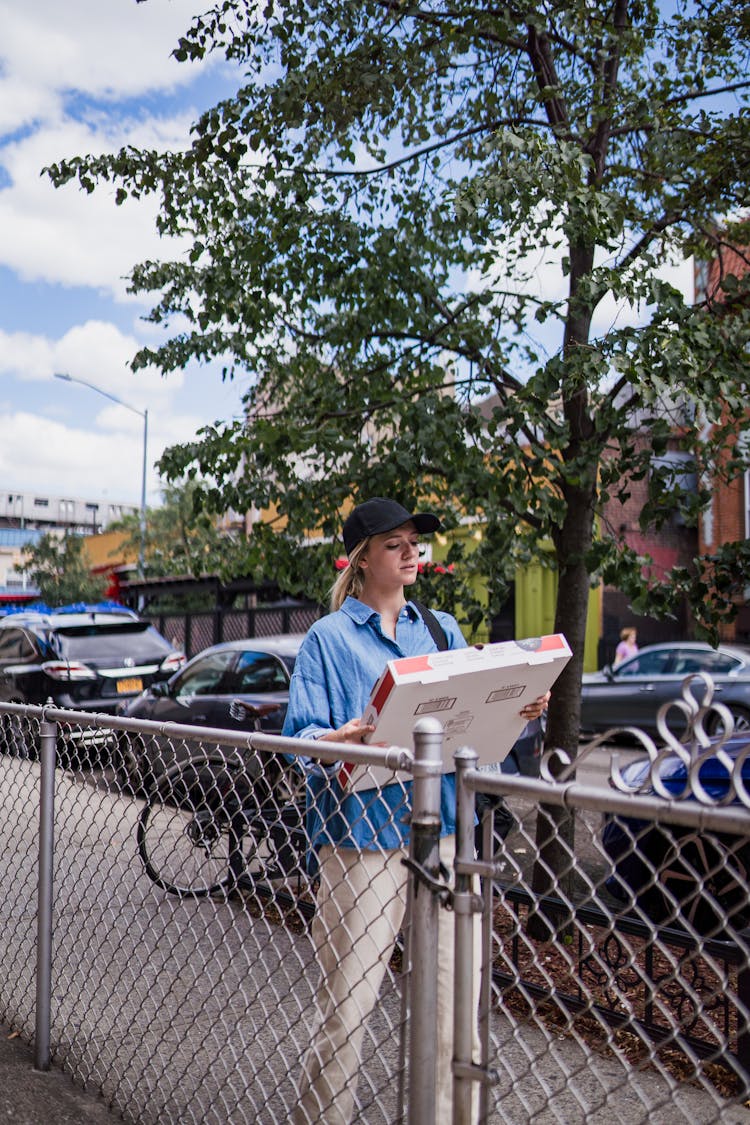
[293,836,480,1125]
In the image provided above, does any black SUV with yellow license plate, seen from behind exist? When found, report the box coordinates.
[0,604,186,712]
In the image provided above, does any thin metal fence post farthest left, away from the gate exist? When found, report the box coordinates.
[34,719,57,1070]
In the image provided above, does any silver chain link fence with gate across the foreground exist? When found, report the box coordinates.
[0,679,750,1125]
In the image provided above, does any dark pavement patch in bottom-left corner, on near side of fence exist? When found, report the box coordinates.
[0,1026,123,1125]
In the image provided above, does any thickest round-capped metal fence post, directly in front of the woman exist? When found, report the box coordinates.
[407,717,443,1125]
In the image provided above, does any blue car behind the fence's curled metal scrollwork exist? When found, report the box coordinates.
[603,734,750,938]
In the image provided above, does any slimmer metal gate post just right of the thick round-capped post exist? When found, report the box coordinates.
[453,747,478,1125]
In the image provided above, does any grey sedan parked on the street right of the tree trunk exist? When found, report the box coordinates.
[581,641,750,735]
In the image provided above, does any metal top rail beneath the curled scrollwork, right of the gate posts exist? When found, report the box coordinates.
[470,765,750,836]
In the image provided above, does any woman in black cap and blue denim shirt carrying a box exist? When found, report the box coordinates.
[283,497,545,1125]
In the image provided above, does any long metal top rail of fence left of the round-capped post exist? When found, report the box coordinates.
[0,703,414,773]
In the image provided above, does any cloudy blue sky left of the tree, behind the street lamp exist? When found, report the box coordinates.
[0,0,244,506]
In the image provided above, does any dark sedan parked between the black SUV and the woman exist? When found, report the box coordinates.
[115,633,302,791]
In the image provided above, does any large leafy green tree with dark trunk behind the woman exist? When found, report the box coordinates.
[48,0,750,913]
